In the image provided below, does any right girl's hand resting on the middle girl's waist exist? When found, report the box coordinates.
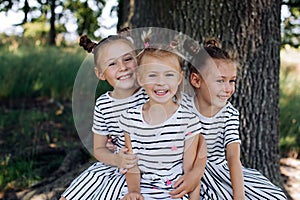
[169,171,200,199]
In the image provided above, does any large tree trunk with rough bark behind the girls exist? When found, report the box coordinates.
[118,0,280,185]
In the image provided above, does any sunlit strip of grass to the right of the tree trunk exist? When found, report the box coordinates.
[280,52,300,158]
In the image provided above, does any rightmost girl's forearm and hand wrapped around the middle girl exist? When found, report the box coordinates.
[170,134,207,198]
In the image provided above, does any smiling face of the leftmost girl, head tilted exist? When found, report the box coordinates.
[95,41,137,89]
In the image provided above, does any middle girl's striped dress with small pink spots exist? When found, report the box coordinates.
[120,106,202,200]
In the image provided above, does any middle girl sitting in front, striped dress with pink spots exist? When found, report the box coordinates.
[119,46,206,200]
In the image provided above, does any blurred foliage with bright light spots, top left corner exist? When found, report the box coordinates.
[0,0,106,44]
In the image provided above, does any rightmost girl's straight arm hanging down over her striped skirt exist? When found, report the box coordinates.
[226,142,245,200]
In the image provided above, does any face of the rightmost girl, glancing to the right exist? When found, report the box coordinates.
[191,59,237,110]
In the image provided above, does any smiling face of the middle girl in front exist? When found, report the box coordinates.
[138,55,182,104]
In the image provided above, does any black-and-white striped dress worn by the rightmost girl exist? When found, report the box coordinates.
[182,96,287,200]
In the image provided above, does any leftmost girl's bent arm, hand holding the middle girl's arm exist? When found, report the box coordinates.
[94,134,137,169]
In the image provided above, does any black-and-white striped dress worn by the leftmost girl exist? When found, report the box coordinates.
[62,89,148,200]
